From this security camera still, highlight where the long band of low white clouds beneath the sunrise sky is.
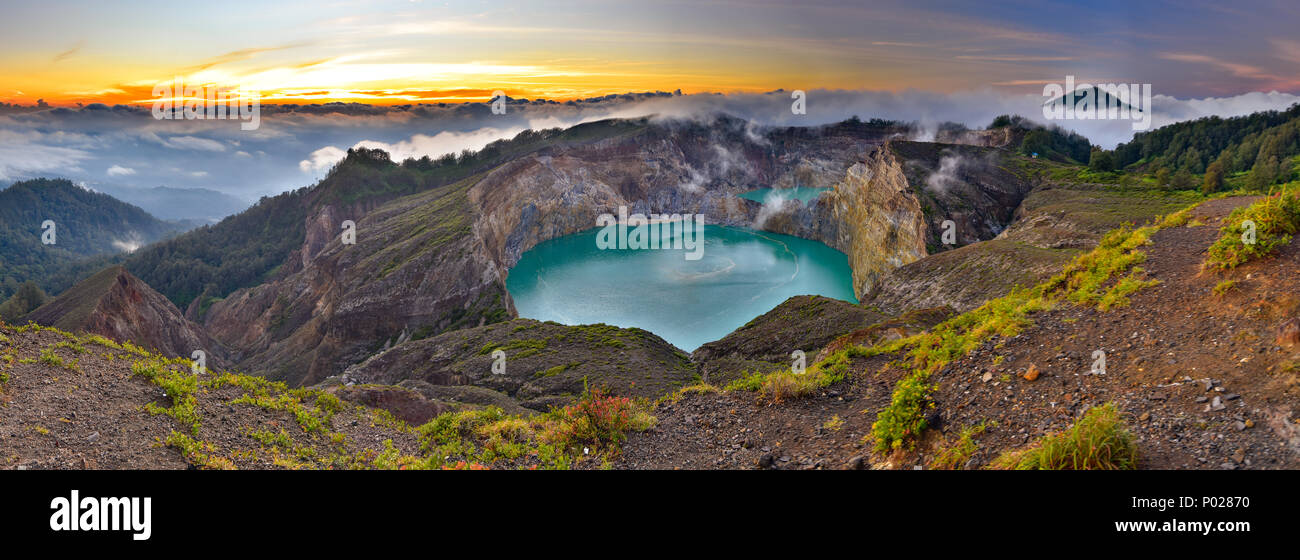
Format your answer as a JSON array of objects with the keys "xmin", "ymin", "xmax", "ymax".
[{"xmin": 0, "ymin": 86, "xmax": 1300, "ymax": 201}]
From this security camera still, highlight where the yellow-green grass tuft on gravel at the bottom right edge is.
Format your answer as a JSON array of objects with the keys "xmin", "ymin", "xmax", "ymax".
[{"xmin": 992, "ymin": 403, "xmax": 1138, "ymax": 470}]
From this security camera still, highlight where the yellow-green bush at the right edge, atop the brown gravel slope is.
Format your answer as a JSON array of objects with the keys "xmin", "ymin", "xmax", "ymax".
[{"xmin": 1205, "ymin": 183, "xmax": 1300, "ymax": 269}]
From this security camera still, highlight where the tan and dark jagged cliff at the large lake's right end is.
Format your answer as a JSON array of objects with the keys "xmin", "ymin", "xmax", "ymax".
[{"xmin": 755, "ymin": 140, "xmax": 1034, "ymax": 299}]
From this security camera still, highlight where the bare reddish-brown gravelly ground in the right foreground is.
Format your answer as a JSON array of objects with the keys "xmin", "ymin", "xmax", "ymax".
[{"xmin": 616, "ymin": 197, "xmax": 1300, "ymax": 469}]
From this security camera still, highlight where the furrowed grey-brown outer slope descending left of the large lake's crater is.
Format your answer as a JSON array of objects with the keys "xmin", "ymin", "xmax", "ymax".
[{"xmin": 204, "ymin": 183, "xmax": 510, "ymax": 385}]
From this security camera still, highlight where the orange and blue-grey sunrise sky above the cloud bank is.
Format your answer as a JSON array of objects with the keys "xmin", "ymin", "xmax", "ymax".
[{"xmin": 0, "ymin": 0, "xmax": 1300, "ymax": 107}]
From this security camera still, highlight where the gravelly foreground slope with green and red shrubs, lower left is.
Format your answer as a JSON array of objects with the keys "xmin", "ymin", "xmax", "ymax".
[{"xmin": 0, "ymin": 324, "xmax": 654, "ymax": 470}]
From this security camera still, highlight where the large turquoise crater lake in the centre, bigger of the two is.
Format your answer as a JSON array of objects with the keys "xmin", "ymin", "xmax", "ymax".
[{"xmin": 506, "ymin": 226, "xmax": 857, "ymax": 352}]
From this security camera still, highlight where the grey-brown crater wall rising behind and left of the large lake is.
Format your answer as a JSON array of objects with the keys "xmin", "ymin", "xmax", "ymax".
[{"xmin": 469, "ymin": 117, "xmax": 898, "ymax": 276}]
